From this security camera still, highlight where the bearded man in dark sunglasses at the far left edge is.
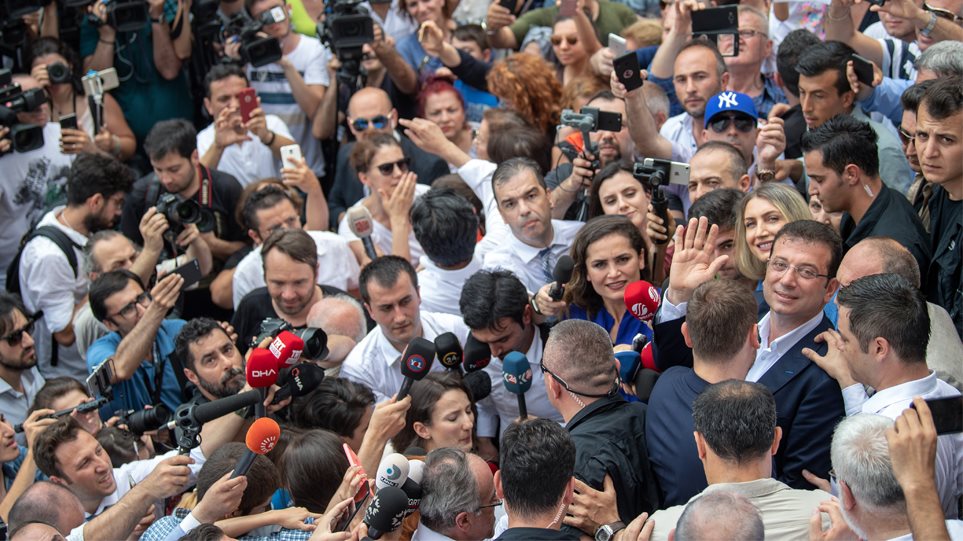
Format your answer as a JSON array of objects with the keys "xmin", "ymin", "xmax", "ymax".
[{"xmin": 0, "ymin": 292, "xmax": 44, "ymax": 438}]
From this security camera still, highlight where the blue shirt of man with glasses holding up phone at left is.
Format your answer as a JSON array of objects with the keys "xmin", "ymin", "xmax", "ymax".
[{"xmin": 87, "ymin": 319, "xmax": 185, "ymax": 419}]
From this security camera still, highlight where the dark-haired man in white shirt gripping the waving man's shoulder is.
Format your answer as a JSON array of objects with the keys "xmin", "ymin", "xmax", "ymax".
[{"xmin": 807, "ymin": 274, "xmax": 963, "ymax": 519}]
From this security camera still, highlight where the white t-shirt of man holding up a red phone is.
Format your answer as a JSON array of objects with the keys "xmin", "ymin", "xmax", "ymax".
[{"xmin": 197, "ymin": 115, "xmax": 294, "ymax": 186}]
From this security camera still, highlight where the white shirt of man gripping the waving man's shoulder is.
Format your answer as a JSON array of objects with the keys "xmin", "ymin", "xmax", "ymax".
[{"xmin": 843, "ymin": 370, "xmax": 963, "ymax": 518}]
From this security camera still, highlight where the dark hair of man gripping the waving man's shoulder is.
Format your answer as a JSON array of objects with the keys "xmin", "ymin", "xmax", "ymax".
[{"xmin": 836, "ymin": 273, "xmax": 930, "ymax": 363}]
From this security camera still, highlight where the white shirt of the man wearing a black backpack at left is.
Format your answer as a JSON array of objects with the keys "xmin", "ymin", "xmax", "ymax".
[{"xmin": 20, "ymin": 207, "xmax": 88, "ymax": 381}]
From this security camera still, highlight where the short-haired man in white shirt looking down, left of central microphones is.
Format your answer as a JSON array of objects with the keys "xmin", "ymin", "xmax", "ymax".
[{"xmin": 341, "ymin": 255, "xmax": 470, "ymax": 402}]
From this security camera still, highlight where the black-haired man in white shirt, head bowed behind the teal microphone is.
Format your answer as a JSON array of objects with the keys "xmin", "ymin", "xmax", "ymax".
[{"xmin": 459, "ymin": 270, "xmax": 563, "ymax": 457}]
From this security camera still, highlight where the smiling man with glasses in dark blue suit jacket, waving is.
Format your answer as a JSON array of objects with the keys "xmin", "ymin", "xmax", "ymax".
[{"xmin": 655, "ymin": 219, "xmax": 844, "ymax": 489}]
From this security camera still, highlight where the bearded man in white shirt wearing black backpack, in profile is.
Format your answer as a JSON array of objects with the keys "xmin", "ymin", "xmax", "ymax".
[{"xmin": 19, "ymin": 154, "xmax": 133, "ymax": 381}]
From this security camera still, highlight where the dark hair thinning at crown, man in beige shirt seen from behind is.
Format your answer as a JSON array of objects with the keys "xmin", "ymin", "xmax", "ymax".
[{"xmin": 692, "ymin": 379, "xmax": 776, "ymax": 463}]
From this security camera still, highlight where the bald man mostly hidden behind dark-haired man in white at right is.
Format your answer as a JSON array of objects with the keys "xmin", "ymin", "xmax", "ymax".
[{"xmin": 836, "ymin": 237, "xmax": 963, "ymax": 392}]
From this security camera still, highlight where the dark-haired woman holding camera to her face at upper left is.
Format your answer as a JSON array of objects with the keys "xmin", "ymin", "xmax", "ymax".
[{"xmin": 30, "ymin": 37, "xmax": 137, "ymax": 160}]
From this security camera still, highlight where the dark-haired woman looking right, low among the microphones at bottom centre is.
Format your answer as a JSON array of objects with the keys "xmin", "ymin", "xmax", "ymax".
[{"xmin": 391, "ymin": 372, "xmax": 475, "ymax": 454}]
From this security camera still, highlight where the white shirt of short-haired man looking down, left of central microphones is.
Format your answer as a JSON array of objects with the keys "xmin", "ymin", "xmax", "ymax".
[{"xmin": 341, "ymin": 311, "xmax": 468, "ymax": 402}]
